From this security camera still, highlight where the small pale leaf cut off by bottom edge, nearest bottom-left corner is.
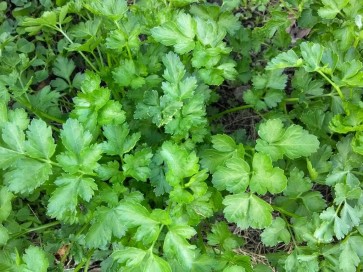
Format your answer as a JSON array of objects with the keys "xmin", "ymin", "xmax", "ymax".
[{"xmin": 22, "ymin": 246, "xmax": 49, "ymax": 272}]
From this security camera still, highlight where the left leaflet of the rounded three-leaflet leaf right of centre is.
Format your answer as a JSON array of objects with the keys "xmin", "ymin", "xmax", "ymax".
[{"xmin": 212, "ymin": 158, "xmax": 250, "ymax": 193}]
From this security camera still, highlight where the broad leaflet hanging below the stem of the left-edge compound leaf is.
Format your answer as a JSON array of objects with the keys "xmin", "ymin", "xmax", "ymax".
[{"xmin": 4, "ymin": 158, "xmax": 52, "ymax": 194}]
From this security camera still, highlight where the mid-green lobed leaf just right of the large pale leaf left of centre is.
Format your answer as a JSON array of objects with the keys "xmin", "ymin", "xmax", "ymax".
[{"xmin": 102, "ymin": 123, "xmax": 141, "ymax": 156}]
